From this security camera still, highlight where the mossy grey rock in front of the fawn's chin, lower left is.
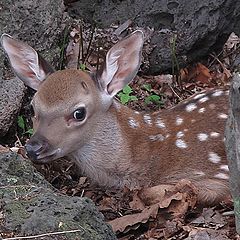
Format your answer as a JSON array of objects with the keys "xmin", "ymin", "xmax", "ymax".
[{"xmin": 0, "ymin": 152, "xmax": 116, "ymax": 240}]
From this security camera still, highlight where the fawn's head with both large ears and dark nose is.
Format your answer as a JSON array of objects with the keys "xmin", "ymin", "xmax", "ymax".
[{"xmin": 1, "ymin": 31, "xmax": 143, "ymax": 163}]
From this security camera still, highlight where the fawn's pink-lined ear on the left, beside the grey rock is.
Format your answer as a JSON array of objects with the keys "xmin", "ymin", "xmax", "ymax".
[{"xmin": 0, "ymin": 34, "xmax": 54, "ymax": 90}]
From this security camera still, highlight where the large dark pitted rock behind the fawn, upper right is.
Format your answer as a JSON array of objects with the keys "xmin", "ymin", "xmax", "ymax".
[{"xmin": 68, "ymin": 0, "xmax": 240, "ymax": 74}]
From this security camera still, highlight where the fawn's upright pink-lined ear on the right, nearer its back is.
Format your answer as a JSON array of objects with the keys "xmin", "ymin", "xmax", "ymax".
[{"xmin": 98, "ymin": 30, "xmax": 144, "ymax": 97}]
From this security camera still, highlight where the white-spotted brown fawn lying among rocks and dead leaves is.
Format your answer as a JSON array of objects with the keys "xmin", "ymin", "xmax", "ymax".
[{"xmin": 1, "ymin": 30, "xmax": 230, "ymax": 205}]
